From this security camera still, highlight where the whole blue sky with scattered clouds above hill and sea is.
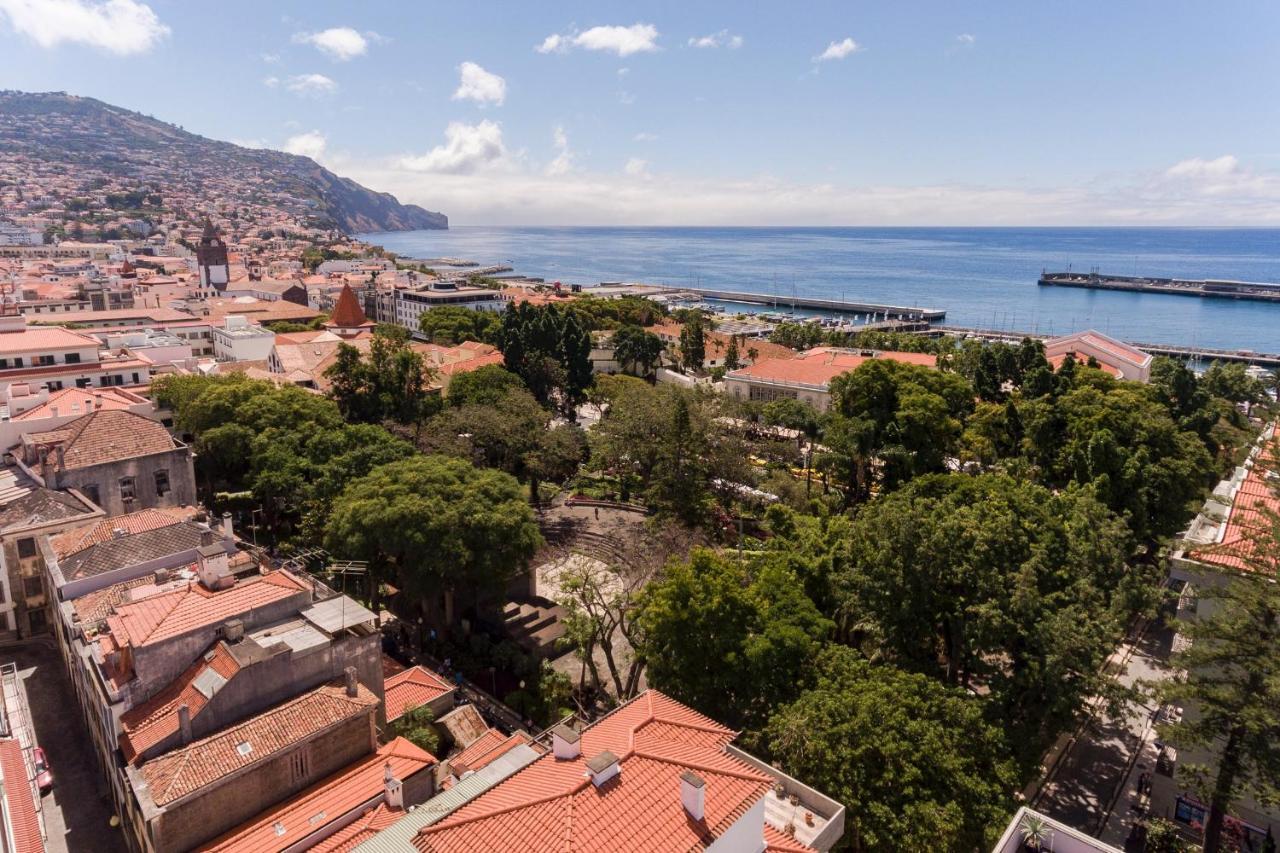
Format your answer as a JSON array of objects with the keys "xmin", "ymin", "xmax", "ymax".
[{"xmin": 0, "ymin": 0, "xmax": 1280, "ymax": 224}]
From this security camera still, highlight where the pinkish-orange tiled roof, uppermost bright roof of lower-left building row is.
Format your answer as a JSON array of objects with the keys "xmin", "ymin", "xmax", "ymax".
[{"xmin": 106, "ymin": 569, "xmax": 306, "ymax": 648}]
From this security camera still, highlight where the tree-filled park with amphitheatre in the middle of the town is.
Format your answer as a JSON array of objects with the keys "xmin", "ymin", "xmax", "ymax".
[{"xmin": 155, "ymin": 300, "xmax": 1280, "ymax": 850}]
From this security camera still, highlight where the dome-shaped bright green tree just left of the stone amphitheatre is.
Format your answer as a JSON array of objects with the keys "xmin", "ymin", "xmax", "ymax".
[{"xmin": 325, "ymin": 456, "xmax": 541, "ymax": 617}]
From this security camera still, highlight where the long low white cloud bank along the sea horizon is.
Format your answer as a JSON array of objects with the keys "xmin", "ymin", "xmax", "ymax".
[{"xmin": 346, "ymin": 151, "xmax": 1280, "ymax": 227}]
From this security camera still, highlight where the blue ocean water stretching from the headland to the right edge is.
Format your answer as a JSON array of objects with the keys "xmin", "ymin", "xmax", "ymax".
[{"xmin": 364, "ymin": 227, "xmax": 1280, "ymax": 352}]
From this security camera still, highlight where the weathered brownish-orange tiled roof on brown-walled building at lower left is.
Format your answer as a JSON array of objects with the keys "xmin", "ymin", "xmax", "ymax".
[{"xmin": 138, "ymin": 684, "xmax": 378, "ymax": 806}]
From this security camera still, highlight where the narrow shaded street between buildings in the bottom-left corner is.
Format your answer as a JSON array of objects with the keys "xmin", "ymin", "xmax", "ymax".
[{"xmin": 0, "ymin": 643, "xmax": 125, "ymax": 853}]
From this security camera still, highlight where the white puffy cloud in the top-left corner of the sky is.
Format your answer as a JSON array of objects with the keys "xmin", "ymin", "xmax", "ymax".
[{"xmin": 0, "ymin": 0, "xmax": 170, "ymax": 56}]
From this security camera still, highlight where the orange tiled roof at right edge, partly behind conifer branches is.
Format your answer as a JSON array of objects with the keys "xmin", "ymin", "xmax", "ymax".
[{"xmin": 1190, "ymin": 435, "xmax": 1280, "ymax": 578}]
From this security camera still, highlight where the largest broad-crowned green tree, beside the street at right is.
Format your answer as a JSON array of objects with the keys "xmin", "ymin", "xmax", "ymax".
[{"xmin": 836, "ymin": 474, "xmax": 1135, "ymax": 758}]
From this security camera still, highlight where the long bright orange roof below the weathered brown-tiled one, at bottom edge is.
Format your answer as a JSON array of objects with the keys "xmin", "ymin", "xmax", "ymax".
[{"xmin": 198, "ymin": 738, "xmax": 435, "ymax": 853}]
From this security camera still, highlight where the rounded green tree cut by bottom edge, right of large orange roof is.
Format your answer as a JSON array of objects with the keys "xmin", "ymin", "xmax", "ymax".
[{"xmin": 767, "ymin": 646, "xmax": 1016, "ymax": 852}]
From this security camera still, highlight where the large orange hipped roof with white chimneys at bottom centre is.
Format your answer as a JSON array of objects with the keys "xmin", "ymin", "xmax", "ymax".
[{"xmin": 413, "ymin": 690, "xmax": 772, "ymax": 853}]
